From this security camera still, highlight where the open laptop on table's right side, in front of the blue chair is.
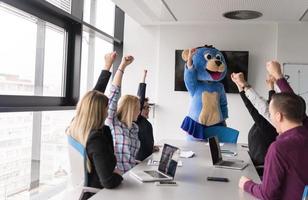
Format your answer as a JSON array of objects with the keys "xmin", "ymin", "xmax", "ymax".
[{"xmin": 208, "ymin": 136, "xmax": 248, "ymax": 170}]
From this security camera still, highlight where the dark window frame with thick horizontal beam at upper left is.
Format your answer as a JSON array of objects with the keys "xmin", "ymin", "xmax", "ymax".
[{"xmin": 0, "ymin": 0, "xmax": 125, "ymax": 112}]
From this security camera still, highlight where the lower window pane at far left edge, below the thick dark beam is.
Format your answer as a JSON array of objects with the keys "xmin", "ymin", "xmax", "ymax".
[{"xmin": 0, "ymin": 112, "xmax": 33, "ymax": 199}]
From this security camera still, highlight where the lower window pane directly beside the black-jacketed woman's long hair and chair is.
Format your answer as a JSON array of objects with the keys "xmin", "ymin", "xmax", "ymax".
[{"xmin": 40, "ymin": 110, "xmax": 75, "ymax": 192}]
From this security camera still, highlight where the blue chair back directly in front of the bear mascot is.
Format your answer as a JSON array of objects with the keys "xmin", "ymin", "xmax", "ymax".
[{"xmin": 205, "ymin": 126, "xmax": 239, "ymax": 144}]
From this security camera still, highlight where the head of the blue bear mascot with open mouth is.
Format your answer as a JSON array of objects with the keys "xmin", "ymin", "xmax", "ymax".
[{"xmin": 182, "ymin": 45, "xmax": 227, "ymax": 81}]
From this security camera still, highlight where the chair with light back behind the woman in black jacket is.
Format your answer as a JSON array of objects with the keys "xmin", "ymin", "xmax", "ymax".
[{"xmin": 67, "ymin": 136, "xmax": 100, "ymax": 200}]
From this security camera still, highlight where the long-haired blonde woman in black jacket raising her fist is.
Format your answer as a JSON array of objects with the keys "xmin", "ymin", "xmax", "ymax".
[{"xmin": 66, "ymin": 52, "xmax": 123, "ymax": 199}]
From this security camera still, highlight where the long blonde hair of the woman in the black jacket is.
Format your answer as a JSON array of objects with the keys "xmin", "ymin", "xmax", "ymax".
[{"xmin": 66, "ymin": 90, "xmax": 108, "ymax": 147}]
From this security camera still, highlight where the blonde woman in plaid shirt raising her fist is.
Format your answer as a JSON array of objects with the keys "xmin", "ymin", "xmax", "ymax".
[{"xmin": 106, "ymin": 56, "xmax": 140, "ymax": 173}]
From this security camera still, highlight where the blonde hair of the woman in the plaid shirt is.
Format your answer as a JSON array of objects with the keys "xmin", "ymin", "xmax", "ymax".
[{"xmin": 117, "ymin": 95, "xmax": 140, "ymax": 128}]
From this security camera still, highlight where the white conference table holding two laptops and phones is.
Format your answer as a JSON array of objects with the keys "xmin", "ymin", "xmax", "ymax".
[{"xmin": 90, "ymin": 140, "xmax": 260, "ymax": 200}]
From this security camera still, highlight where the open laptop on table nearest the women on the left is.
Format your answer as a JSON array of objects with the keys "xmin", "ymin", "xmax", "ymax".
[{"xmin": 130, "ymin": 144, "xmax": 180, "ymax": 182}]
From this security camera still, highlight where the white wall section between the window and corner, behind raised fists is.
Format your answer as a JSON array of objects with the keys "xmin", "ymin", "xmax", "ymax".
[{"xmin": 122, "ymin": 15, "xmax": 159, "ymax": 102}]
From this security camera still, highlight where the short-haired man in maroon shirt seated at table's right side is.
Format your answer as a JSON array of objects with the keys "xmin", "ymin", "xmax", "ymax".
[{"xmin": 239, "ymin": 63, "xmax": 308, "ymax": 200}]
